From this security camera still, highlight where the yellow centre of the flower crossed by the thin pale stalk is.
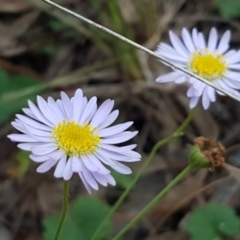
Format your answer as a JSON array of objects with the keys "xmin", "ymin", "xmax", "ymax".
[{"xmin": 189, "ymin": 50, "xmax": 227, "ymax": 81}]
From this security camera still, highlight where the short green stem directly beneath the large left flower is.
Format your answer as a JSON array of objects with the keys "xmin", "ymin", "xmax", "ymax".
[{"xmin": 54, "ymin": 181, "xmax": 69, "ymax": 240}]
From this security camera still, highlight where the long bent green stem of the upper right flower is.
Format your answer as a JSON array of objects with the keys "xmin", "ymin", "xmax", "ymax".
[{"xmin": 91, "ymin": 109, "xmax": 195, "ymax": 240}]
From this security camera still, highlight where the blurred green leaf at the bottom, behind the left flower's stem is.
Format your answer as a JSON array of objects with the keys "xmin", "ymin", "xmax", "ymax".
[{"xmin": 44, "ymin": 196, "xmax": 112, "ymax": 240}]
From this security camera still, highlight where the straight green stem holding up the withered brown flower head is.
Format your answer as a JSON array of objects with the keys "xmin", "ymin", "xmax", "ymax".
[{"xmin": 112, "ymin": 165, "xmax": 194, "ymax": 240}]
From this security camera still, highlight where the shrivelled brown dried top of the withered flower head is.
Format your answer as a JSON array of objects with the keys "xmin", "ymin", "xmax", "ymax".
[{"xmin": 194, "ymin": 137, "xmax": 226, "ymax": 171}]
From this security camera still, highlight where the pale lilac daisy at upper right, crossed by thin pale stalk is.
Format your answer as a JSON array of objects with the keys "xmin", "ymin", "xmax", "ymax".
[{"xmin": 155, "ymin": 28, "xmax": 240, "ymax": 109}]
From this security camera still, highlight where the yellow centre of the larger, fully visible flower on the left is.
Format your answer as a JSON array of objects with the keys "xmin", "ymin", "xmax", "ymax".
[{"xmin": 52, "ymin": 120, "xmax": 100, "ymax": 156}]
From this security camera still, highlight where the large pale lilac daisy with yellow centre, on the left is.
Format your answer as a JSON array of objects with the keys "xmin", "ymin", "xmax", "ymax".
[{"xmin": 8, "ymin": 89, "xmax": 141, "ymax": 193}]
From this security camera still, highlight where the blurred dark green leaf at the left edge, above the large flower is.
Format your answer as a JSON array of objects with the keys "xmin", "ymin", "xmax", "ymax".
[{"xmin": 0, "ymin": 69, "xmax": 44, "ymax": 121}]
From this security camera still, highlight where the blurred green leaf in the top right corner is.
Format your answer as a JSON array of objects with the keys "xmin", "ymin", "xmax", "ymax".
[{"xmin": 214, "ymin": 0, "xmax": 240, "ymax": 18}]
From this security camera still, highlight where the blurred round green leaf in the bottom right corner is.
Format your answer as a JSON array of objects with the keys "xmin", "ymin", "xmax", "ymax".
[{"xmin": 186, "ymin": 202, "xmax": 240, "ymax": 240}]
